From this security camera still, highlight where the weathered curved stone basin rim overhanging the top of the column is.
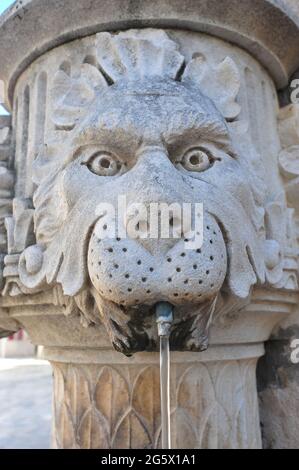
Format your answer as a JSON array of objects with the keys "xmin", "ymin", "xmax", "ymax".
[{"xmin": 0, "ymin": 0, "xmax": 299, "ymax": 107}]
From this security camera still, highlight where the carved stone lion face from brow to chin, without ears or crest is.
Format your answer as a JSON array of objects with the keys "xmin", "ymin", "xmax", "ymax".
[{"xmin": 20, "ymin": 29, "xmax": 264, "ymax": 353}]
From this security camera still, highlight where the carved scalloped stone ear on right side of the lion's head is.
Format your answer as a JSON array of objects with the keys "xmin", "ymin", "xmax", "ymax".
[{"xmin": 182, "ymin": 55, "xmax": 241, "ymax": 121}]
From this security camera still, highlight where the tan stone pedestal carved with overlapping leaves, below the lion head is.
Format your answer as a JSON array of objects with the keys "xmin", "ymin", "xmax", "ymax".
[{"xmin": 45, "ymin": 345, "xmax": 263, "ymax": 449}]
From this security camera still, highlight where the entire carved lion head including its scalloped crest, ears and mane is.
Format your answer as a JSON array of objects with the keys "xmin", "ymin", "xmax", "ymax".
[{"xmin": 4, "ymin": 29, "xmax": 296, "ymax": 354}]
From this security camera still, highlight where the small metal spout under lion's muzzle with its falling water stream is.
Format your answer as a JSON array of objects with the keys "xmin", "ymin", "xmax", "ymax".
[{"xmin": 156, "ymin": 302, "xmax": 173, "ymax": 449}]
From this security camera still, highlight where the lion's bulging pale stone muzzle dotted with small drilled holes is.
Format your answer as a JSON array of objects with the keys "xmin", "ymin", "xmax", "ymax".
[{"xmin": 88, "ymin": 215, "xmax": 227, "ymax": 307}]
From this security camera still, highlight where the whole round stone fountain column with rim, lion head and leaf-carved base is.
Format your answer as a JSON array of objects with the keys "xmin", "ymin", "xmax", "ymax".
[{"xmin": 0, "ymin": 0, "xmax": 299, "ymax": 449}]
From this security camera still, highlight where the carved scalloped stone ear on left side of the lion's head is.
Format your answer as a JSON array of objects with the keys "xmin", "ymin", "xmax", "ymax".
[{"xmin": 51, "ymin": 64, "xmax": 108, "ymax": 130}]
